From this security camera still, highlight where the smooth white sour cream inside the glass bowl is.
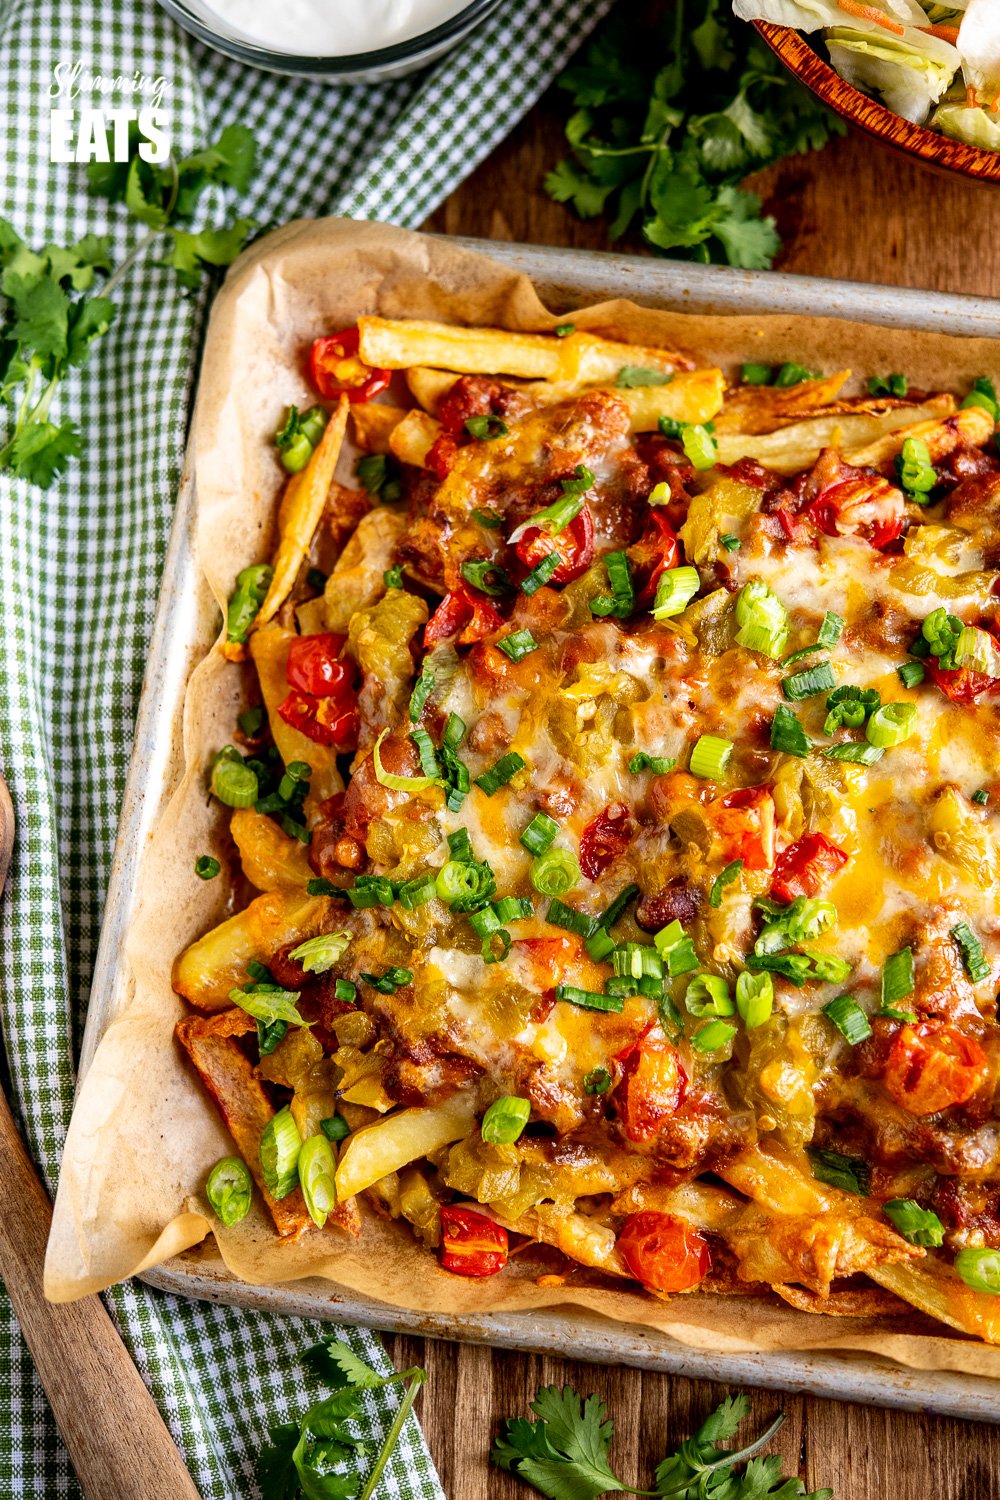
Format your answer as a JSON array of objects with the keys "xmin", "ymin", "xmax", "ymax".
[{"xmin": 190, "ymin": 0, "xmax": 469, "ymax": 57}]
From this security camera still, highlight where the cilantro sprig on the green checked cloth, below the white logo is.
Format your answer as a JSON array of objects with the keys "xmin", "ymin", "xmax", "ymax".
[{"xmin": 0, "ymin": 125, "xmax": 255, "ymax": 489}]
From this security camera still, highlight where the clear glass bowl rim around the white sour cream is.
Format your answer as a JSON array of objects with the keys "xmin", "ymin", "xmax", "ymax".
[{"xmin": 159, "ymin": 0, "xmax": 501, "ymax": 84}]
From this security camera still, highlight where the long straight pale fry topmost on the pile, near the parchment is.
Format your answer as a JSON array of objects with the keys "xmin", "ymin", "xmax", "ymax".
[{"xmin": 358, "ymin": 318, "xmax": 691, "ymax": 384}]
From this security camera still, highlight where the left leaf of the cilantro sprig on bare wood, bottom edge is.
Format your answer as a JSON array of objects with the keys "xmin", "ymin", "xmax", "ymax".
[{"xmin": 492, "ymin": 1386, "xmax": 625, "ymax": 1500}]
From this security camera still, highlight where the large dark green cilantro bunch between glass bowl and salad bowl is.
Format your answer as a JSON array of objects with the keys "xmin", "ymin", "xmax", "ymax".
[{"xmin": 546, "ymin": 0, "xmax": 844, "ymax": 270}]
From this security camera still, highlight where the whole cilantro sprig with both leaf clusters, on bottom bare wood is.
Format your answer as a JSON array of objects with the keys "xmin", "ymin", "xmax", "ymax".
[{"xmin": 490, "ymin": 1386, "xmax": 834, "ymax": 1500}]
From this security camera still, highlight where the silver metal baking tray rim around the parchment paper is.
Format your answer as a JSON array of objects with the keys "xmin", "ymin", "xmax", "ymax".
[{"xmin": 79, "ymin": 240, "xmax": 1000, "ymax": 1422}]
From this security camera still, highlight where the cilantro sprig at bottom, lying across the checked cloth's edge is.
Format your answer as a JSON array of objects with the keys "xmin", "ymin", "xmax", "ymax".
[{"xmin": 256, "ymin": 1338, "xmax": 427, "ymax": 1500}]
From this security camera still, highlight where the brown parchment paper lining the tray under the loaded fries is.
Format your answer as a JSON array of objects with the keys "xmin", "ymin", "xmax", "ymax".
[{"xmin": 45, "ymin": 219, "xmax": 1000, "ymax": 1376}]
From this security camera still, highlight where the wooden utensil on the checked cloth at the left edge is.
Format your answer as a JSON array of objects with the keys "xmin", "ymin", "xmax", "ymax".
[{"xmin": 0, "ymin": 779, "xmax": 198, "ymax": 1500}]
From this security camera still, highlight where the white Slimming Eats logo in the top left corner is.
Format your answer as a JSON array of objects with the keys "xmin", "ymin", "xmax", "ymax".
[{"xmin": 48, "ymin": 62, "xmax": 171, "ymax": 164}]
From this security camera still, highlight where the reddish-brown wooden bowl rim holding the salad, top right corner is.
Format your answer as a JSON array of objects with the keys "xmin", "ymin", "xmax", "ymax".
[{"xmin": 754, "ymin": 21, "xmax": 1000, "ymax": 183}]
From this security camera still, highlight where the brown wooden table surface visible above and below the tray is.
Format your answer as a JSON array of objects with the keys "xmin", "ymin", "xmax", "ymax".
[{"xmin": 404, "ymin": 79, "xmax": 1000, "ymax": 1500}]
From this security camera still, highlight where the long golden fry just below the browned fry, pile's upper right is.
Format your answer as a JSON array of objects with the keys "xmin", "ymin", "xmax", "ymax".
[{"xmin": 717, "ymin": 396, "xmax": 955, "ymax": 474}]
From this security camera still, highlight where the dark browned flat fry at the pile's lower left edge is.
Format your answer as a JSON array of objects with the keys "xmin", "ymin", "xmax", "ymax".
[{"xmin": 175, "ymin": 1011, "xmax": 312, "ymax": 1239}]
